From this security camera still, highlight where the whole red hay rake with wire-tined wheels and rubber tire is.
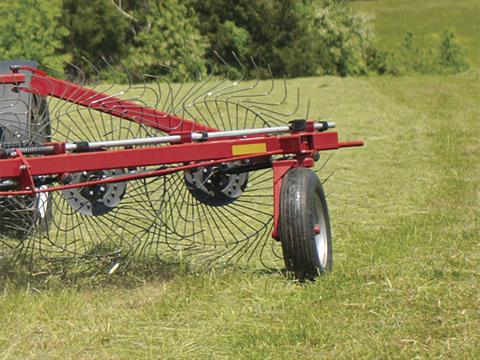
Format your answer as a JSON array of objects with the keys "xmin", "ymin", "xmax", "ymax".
[{"xmin": 0, "ymin": 62, "xmax": 362, "ymax": 278}]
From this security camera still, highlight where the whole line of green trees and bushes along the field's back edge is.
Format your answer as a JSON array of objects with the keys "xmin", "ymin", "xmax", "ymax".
[{"xmin": 0, "ymin": 0, "xmax": 468, "ymax": 81}]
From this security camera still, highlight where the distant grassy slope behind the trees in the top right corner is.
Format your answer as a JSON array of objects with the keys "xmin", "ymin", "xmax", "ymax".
[{"xmin": 351, "ymin": 0, "xmax": 480, "ymax": 67}]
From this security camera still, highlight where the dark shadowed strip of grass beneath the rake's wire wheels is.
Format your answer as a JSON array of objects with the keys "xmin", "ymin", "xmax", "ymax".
[{"xmin": 0, "ymin": 257, "xmax": 288, "ymax": 291}]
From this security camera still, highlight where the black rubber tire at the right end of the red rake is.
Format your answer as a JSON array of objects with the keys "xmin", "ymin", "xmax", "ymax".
[{"xmin": 279, "ymin": 168, "xmax": 333, "ymax": 280}]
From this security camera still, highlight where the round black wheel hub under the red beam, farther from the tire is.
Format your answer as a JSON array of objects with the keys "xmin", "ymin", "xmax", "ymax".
[{"xmin": 62, "ymin": 169, "xmax": 127, "ymax": 216}]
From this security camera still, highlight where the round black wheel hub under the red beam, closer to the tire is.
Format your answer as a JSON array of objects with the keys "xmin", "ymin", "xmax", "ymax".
[{"xmin": 185, "ymin": 161, "xmax": 248, "ymax": 206}]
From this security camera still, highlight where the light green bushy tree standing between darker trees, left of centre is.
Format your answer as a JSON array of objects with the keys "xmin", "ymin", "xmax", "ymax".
[{"xmin": 125, "ymin": 0, "xmax": 206, "ymax": 80}]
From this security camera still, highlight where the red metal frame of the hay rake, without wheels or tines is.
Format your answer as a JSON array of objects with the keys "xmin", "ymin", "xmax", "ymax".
[{"xmin": 0, "ymin": 66, "xmax": 363, "ymax": 276}]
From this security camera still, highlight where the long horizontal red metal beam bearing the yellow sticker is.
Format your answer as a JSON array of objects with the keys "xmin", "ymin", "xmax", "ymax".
[{"xmin": 0, "ymin": 132, "xmax": 338, "ymax": 178}]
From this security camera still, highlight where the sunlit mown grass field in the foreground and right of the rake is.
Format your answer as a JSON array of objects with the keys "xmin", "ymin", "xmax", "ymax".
[{"xmin": 0, "ymin": 71, "xmax": 480, "ymax": 359}]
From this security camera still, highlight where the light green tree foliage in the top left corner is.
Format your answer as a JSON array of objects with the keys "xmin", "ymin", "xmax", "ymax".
[{"xmin": 0, "ymin": 0, "xmax": 70, "ymax": 70}]
